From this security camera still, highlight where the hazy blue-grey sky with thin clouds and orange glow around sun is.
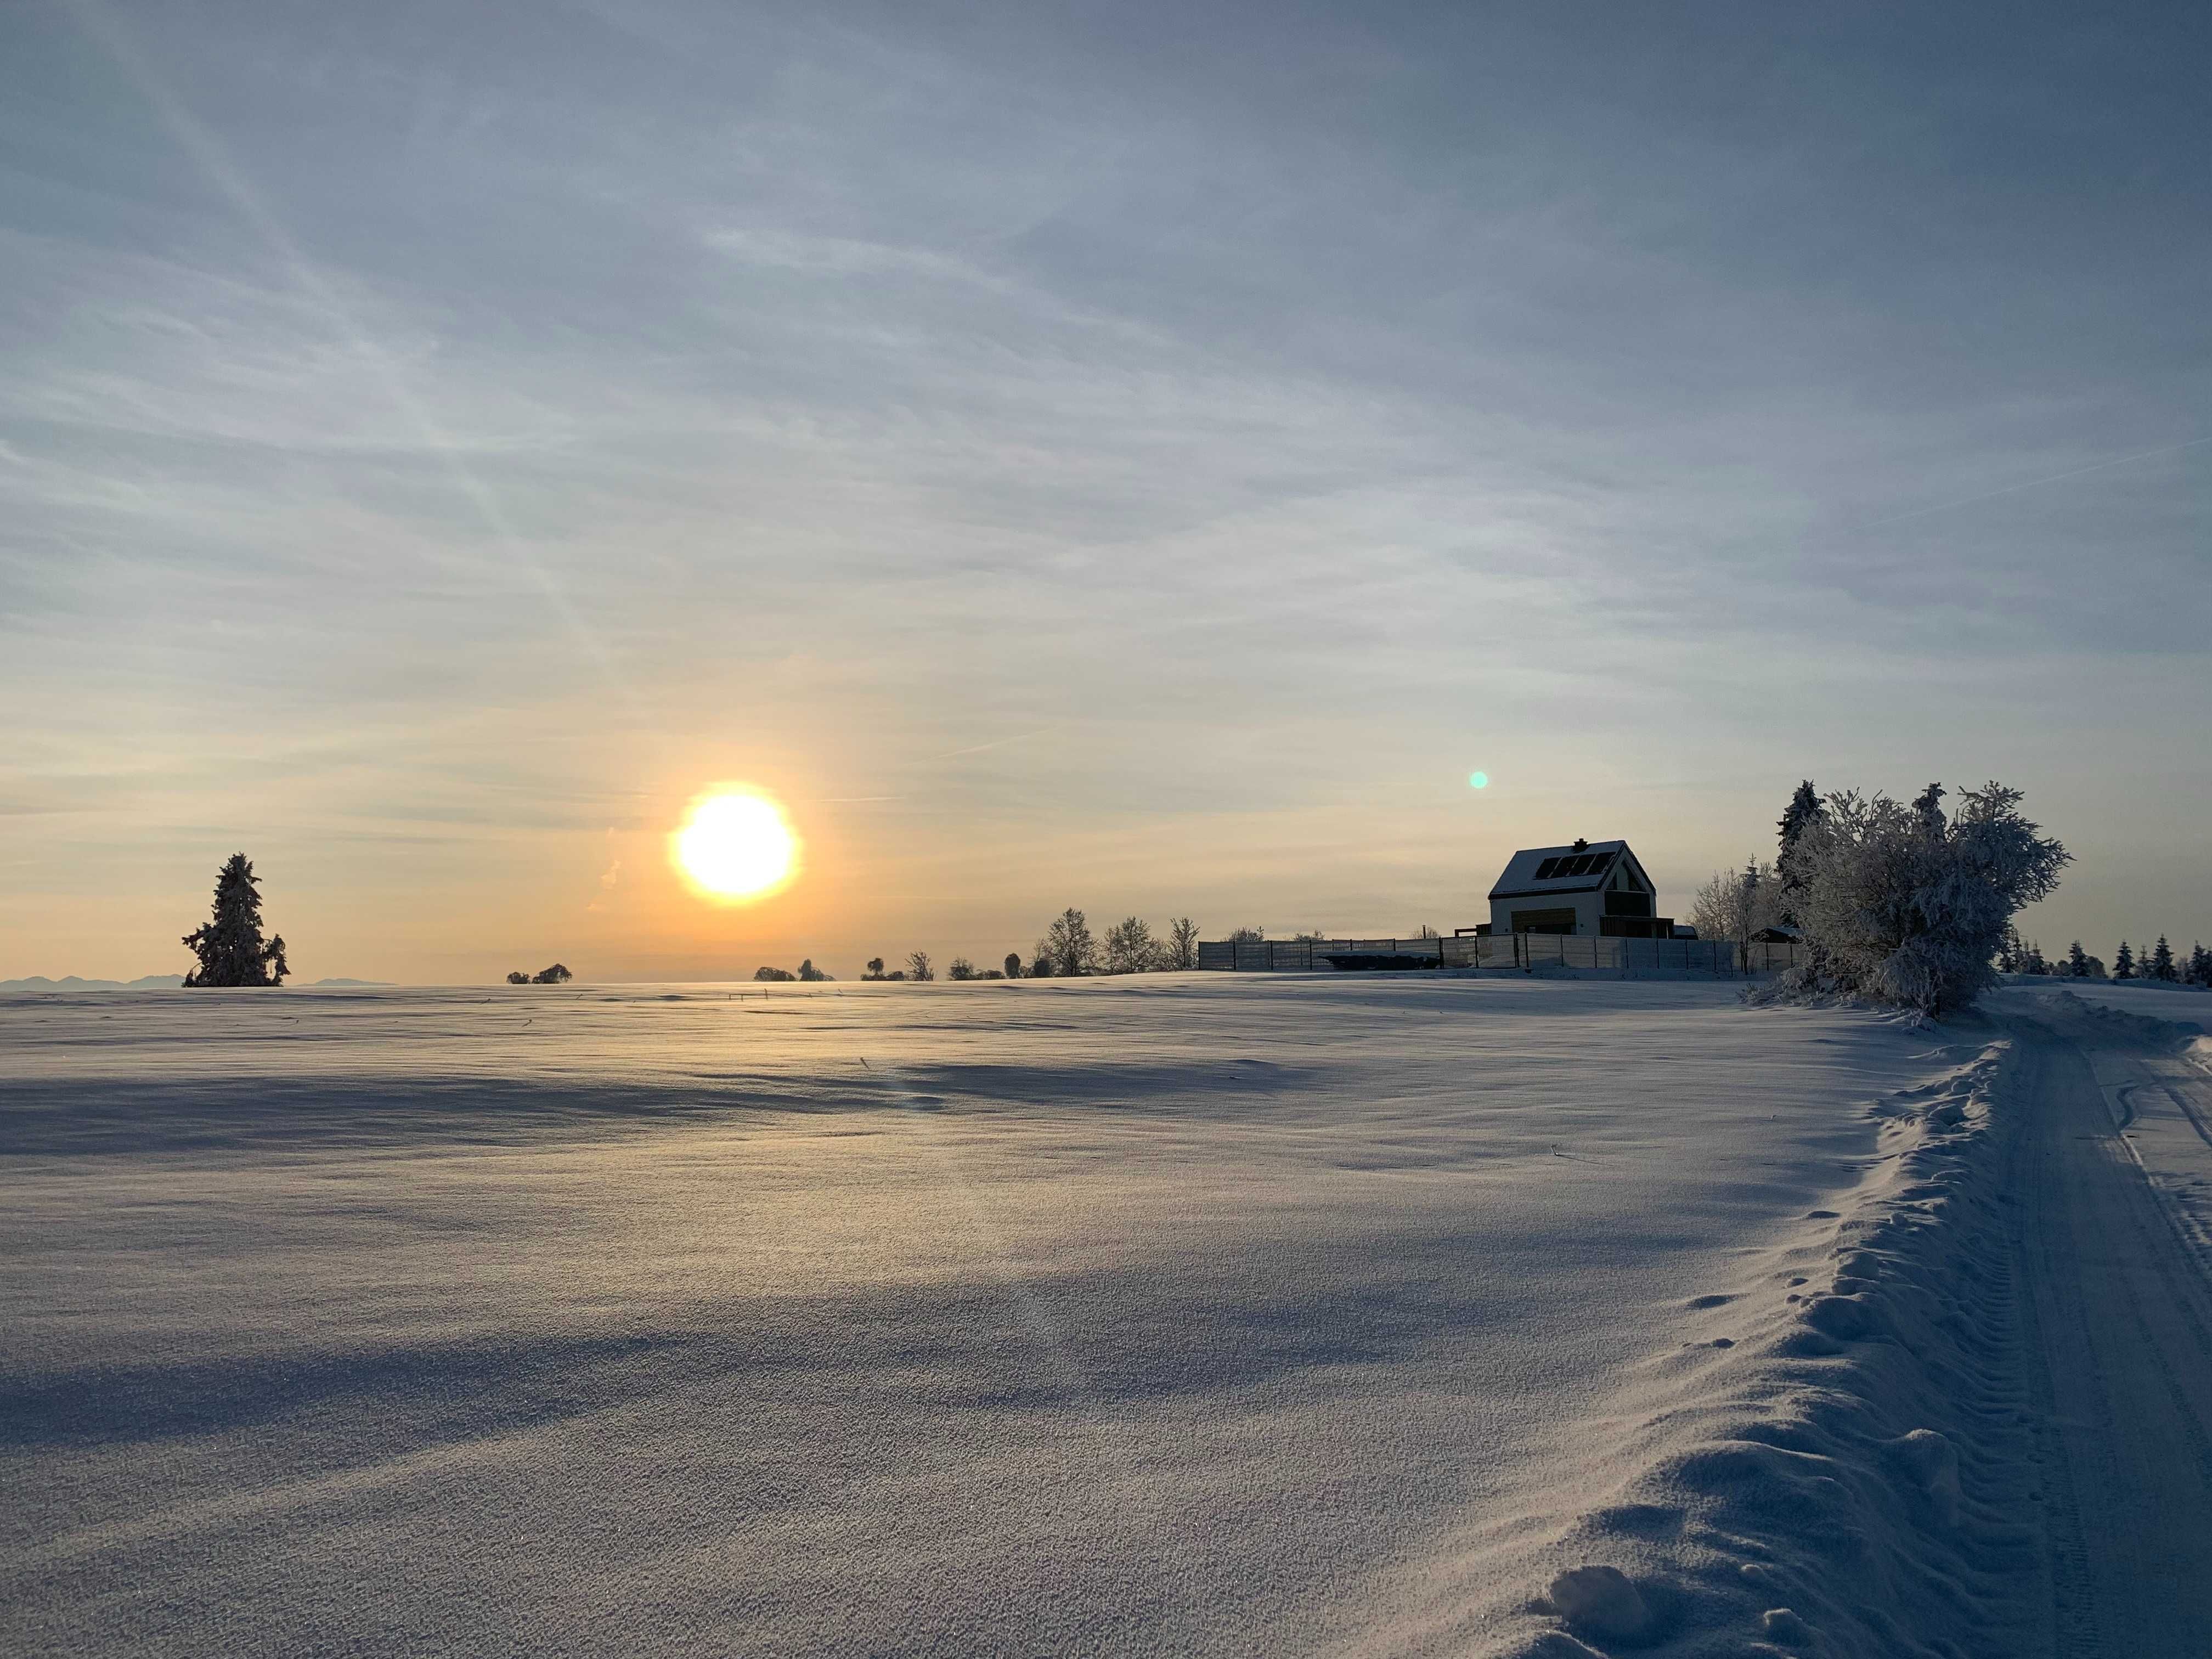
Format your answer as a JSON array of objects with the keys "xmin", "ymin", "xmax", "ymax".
[{"xmin": 0, "ymin": 0, "xmax": 2212, "ymax": 982}]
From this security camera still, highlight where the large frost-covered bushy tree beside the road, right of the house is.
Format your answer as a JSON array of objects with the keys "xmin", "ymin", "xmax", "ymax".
[{"xmin": 1754, "ymin": 783, "xmax": 2070, "ymax": 1015}]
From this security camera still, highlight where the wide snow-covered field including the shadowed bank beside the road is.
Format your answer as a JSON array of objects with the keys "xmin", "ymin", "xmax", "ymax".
[{"xmin": 0, "ymin": 975, "xmax": 2042, "ymax": 1657}]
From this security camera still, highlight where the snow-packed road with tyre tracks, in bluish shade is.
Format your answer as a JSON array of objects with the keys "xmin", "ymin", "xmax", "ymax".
[{"xmin": 1995, "ymin": 991, "xmax": 2212, "ymax": 1659}]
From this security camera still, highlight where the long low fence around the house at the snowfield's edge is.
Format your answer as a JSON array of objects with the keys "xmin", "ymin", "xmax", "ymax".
[{"xmin": 1199, "ymin": 934, "xmax": 1801, "ymax": 980}]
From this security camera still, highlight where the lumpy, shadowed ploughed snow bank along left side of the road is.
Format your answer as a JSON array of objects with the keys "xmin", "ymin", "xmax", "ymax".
[{"xmin": 1493, "ymin": 1042, "xmax": 2044, "ymax": 1659}]
